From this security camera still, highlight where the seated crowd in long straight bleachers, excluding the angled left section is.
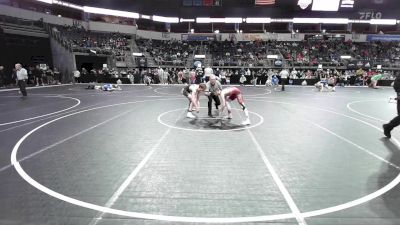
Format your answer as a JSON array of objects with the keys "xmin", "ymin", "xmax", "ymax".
[{"xmin": 132, "ymin": 39, "xmax": 400, "ymax": 68}]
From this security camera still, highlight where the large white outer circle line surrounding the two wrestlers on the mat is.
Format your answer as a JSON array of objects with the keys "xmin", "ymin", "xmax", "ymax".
[{"xmin": 11, "ymin": 99, "xmax": 400, "ymax": 223}]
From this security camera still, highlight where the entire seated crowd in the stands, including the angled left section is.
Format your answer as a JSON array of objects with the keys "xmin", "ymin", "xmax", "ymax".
[{"xmin": 46, "ymin": 22, "xmax": 400, "ymax": 68}]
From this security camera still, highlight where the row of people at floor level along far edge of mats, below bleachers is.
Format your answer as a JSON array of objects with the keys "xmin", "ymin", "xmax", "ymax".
[{"xmin": 67, "ymin": 63, "xmax": 395, "ymax": 86}]
